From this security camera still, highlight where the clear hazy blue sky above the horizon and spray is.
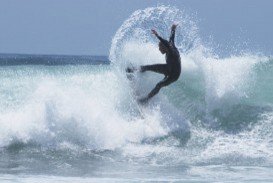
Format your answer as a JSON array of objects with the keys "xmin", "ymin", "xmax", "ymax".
[{"xmin": 0, "ymin": 0, "xmax": 273, "ymax": 55}]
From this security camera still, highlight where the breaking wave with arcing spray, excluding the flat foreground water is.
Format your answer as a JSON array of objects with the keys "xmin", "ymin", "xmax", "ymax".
[{"xmin": 0, "ymin": 6, "xmax": 273, "ymax": 170}]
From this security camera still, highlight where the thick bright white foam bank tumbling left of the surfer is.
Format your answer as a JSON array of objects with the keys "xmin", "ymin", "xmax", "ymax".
[{"xmin": 0, "ymin": 67, "xmax": 176, "ymax": 149}]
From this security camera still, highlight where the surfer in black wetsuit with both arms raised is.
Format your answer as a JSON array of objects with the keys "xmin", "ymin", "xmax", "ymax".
[{"xmin": 126, "ymin": 24, "xmax": 181, "ymax": 103}]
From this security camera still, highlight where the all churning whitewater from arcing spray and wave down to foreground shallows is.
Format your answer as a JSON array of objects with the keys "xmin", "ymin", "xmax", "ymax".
[{"xmin": 0, "ymin": 6, "xmax": 273, "ymax": 182}]
